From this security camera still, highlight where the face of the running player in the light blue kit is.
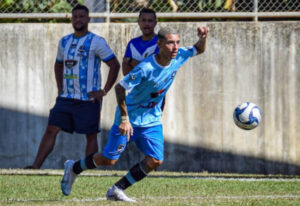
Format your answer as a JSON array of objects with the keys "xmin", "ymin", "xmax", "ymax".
[{"xmin": 158, "ymin": 34, "xmax": 180, "ymax": 59}]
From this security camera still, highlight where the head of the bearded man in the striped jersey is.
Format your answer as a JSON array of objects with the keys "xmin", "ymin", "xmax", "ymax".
[{"xmin": 72, "ymin": 9, "xmax": 90, "ymax": 31}]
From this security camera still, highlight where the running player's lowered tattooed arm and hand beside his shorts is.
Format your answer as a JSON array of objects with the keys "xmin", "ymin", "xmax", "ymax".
[{"xmin": 115, "ymin": 84, "xmax": 133, "ymax": 141}]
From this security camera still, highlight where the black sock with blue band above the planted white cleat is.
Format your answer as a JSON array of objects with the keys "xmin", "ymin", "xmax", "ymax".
[{"xmin": 115, "ymin": 162, "xmax": 148, "ymax": 190}]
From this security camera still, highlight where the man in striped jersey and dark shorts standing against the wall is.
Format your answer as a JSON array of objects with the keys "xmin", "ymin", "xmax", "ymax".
[{"xmin": 27, "ymin": 5, "xmax": 120, "ymax": 169}]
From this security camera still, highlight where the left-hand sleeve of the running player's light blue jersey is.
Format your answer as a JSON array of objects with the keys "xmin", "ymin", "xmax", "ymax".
[{"xmin": 119, "ymin": 65, "xmax": 145, "ymax": 90}]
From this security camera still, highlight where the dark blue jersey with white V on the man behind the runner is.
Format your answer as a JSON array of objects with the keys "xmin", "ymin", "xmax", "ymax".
[{"xmin": 124, "ymin": 35, "xmax": 159, "ymax": 61}]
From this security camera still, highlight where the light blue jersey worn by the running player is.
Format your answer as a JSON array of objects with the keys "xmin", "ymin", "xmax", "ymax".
[{"xmin": 115, "ymin": 47, "xmax": 197, "ymax": 127}]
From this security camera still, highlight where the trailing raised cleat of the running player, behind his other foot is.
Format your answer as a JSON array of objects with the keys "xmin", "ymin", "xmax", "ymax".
[{"xmin": 60, "ymin": 160, "xmax": 77, "ymax": 195}]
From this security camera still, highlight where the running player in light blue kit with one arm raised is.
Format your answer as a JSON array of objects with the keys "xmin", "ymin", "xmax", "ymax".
[{"xmin": 61, "ymin": 27, "xmax": 209, "ymax": 202}]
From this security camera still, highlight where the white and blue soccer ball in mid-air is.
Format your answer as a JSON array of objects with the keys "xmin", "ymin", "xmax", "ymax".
[{"xmin": 233, "ymin": 102, "xmax": 262, "ymax": 130}]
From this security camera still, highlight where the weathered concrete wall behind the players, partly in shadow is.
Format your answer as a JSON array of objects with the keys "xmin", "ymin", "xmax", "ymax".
[{"xmin": 0, "ymin": 22, "xmax": 300, "ymax": 174}]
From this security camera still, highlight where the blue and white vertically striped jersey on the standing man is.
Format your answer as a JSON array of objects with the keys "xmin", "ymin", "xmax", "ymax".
[{"xmin": 56, "ymin": 32, "xmax": 115, "ymax": 100}]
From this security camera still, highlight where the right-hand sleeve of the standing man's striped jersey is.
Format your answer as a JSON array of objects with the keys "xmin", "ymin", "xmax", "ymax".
[{"xmin": 95, "ymin": 38, "xmax": 115, "ymax": 62}]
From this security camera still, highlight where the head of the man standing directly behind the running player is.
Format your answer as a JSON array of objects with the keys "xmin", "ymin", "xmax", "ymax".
[{"xmin": 138, "ymin": 13, "xmax": 156, "ymax": 36}]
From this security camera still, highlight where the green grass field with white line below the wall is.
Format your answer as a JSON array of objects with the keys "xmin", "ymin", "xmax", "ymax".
[{"xmin": 0, "ymin": 169, "xmax": 300, "ymax": 206}]
